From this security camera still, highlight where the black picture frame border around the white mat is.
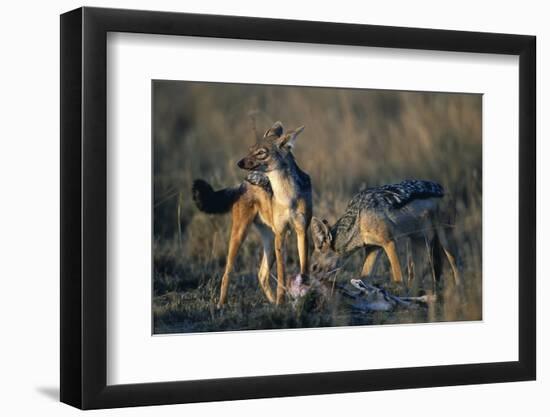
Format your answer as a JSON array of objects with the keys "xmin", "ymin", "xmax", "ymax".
[{"xmin": 60, "ymin": 7, "xmax": 536, "ymax": 409}]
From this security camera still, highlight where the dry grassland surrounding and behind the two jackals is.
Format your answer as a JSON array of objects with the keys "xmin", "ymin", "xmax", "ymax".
[{"xmin": 152, "ymin": 81, "xmax": 482, "ymax": 333}]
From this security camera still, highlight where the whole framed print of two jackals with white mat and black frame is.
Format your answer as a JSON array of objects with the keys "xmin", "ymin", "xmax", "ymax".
[{"xmin": 61, "ymin": 8, "xmax": 536, "ymax": 409}]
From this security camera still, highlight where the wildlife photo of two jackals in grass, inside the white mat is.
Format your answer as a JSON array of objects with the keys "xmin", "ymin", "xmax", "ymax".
[{"xmin": 150, "ymin": 79, "xmax": 483, "ymax": 335}]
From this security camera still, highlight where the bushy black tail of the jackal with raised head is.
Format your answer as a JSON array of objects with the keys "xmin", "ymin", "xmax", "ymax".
[{"xmin": 192, "ymin": 180, "xmax": 243, "ymax": 214}]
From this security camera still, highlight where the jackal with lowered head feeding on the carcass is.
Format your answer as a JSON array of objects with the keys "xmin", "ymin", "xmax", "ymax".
[{"xmin": 311, "ymin": 180, "xmax": 460, "ymax": 285}]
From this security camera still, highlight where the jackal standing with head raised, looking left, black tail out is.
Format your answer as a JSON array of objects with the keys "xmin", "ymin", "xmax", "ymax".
[{"xmin": 193, "ymin": 122, "xmax": 312, "ymax": 307}]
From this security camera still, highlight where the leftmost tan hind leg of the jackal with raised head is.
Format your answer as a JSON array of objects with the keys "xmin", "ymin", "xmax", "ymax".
[{"xmin": 218, "ymin": 202, "xmax": 256, "ymax": 308}]
